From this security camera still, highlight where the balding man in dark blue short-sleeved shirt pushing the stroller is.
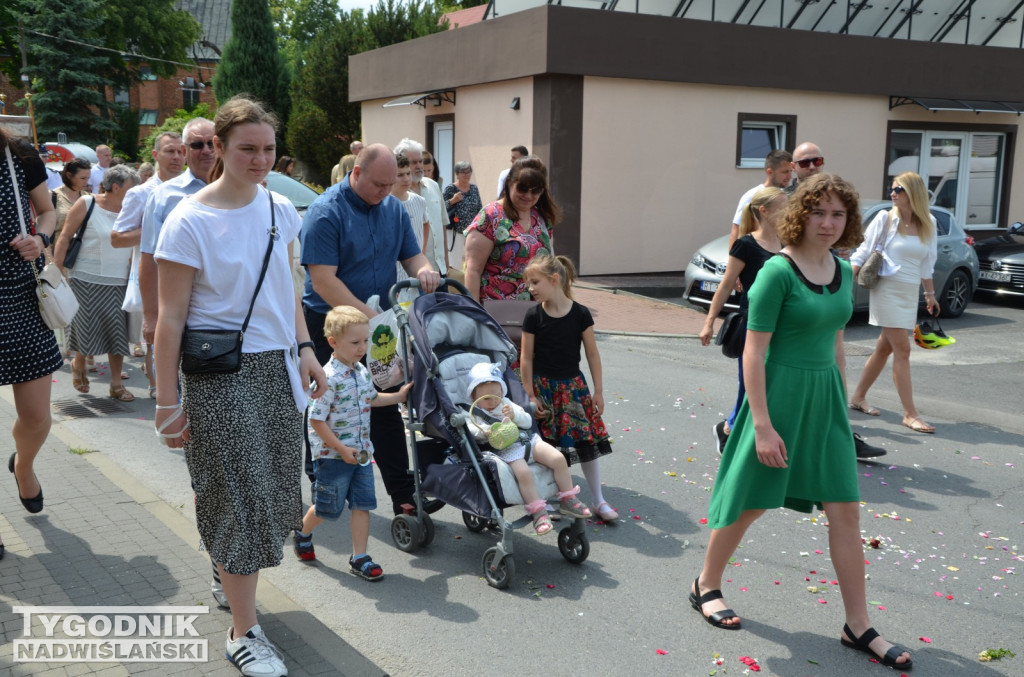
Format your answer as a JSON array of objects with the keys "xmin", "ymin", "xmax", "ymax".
[{"xmin": 301, "ymin": 143, "xmax": 440, "ymax": 514}]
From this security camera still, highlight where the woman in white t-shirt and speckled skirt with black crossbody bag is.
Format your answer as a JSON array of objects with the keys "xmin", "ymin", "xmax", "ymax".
[{"xmin": 154, "ymin": 96, "xmax": 326, "ymax": 675}]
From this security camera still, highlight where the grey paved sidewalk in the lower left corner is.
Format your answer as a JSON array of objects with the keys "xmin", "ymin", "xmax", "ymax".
[{"xmin": 0, "ymin": 389, "xmax": 384, "ymax": 677}]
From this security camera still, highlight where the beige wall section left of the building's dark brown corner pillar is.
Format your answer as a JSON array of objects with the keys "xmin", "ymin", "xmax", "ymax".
[{"xmin": 362, "ymin": 78, "xmax": 534, "ymax": 195}]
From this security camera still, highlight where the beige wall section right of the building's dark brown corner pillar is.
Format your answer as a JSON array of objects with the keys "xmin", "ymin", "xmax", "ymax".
[{"xmin": 580, "ymin": 77, "xmax": 1024, "ymax": 274}]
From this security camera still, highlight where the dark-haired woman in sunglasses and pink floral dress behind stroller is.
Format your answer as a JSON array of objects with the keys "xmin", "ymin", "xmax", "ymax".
[{"xmin": 465, "ymin": 157, "xmax": 561, "ymax": 301}]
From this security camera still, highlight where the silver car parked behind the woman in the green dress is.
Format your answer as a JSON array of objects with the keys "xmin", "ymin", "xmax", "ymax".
[{"xmin": 683, "ymin": 202, "xmax": 979, "ymax": 318}]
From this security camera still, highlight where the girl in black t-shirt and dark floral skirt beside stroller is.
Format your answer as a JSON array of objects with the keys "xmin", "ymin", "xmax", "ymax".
[{"xmin": 520, "ymin": 254, "xmax": 618, "ymax": 521}]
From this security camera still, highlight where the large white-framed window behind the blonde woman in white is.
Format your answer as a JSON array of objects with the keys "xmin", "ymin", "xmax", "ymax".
[{"xmin": 883, "ymin": 123, "xmax": 1011, "ymax": 228}]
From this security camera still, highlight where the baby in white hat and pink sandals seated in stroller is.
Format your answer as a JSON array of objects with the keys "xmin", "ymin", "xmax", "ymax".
[{"xmin": 467, "ymin": 363, "xmax": 591, "ymax": 534}]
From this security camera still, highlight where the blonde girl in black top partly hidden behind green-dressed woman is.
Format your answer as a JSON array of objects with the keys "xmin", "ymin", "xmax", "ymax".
[{"xmin": 698, "ymin": 186, "xmax": 786, "ymax": 446}]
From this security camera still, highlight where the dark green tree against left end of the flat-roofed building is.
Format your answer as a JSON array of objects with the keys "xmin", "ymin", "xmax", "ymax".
[{"xmin": 288, "ymin": 0, "xmax": 447, "ymax": 183}]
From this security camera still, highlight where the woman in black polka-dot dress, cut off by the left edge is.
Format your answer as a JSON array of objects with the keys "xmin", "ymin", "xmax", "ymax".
[{"xmin": 0, "ymin": 128, "xmax": 62, "ymax": 544}]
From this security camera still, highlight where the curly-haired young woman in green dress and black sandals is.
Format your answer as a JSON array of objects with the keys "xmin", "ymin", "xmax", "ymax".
[{"xmin": 689, "ymin": 174, "xmax": 912, "ymax": 670}]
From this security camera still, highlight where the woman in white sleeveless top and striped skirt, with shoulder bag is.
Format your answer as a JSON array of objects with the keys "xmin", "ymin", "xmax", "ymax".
[{"xmin": 53, "ymin": 165, "xmax": 139, "ymax": 401}]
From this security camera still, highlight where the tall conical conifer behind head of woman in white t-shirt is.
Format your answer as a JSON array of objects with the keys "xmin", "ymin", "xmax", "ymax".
[{"xmin": 213, "ymin": 0, "xmax": 290, "ymax": 122}]
